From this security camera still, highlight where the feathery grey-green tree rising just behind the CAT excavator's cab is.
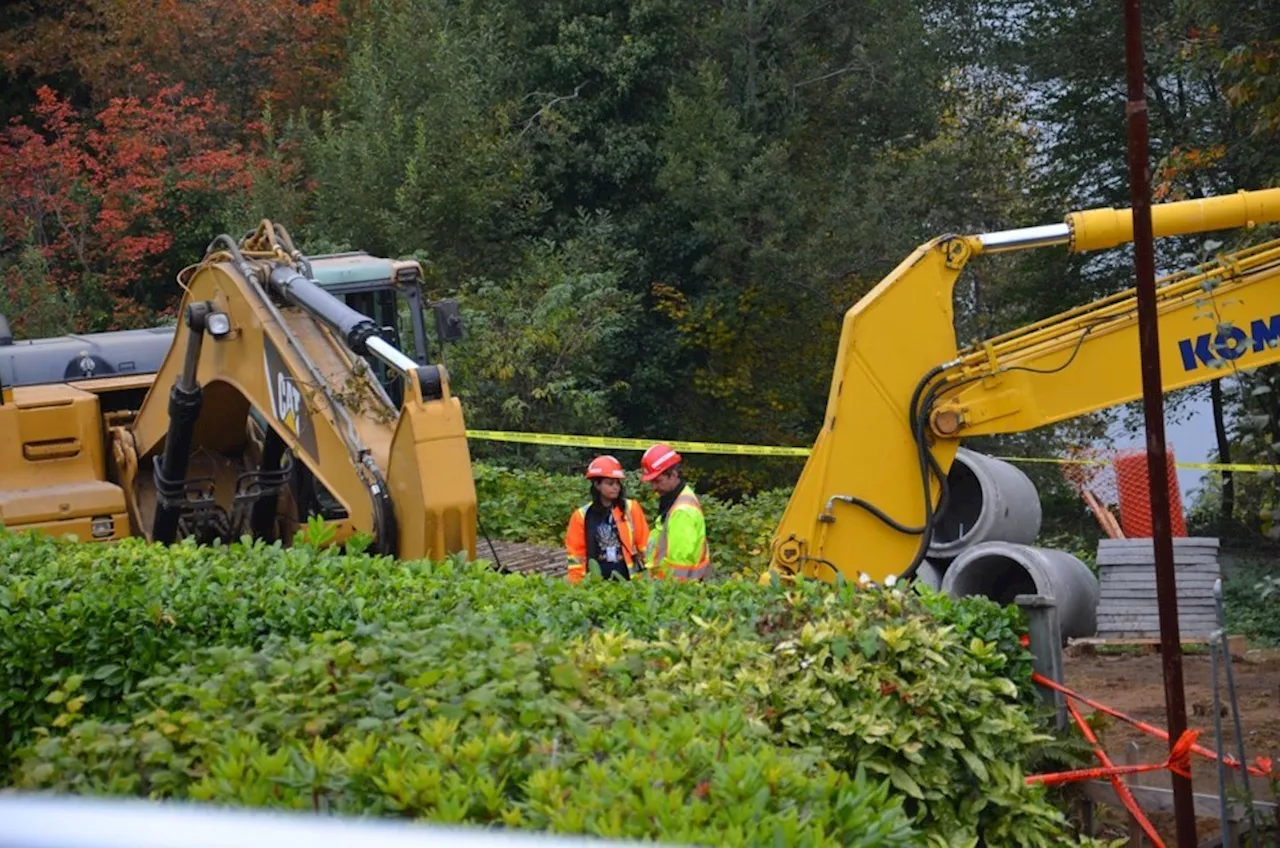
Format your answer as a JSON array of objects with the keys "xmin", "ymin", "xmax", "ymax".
[{"xmin": 297, "ymin": 0, "xmax": 529, "ymax": 291}]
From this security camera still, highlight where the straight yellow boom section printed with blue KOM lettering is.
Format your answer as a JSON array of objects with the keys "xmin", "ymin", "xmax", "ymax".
[{"xmin": 931, "ymin": 241, "xmax": 1280, "ymax": 438}]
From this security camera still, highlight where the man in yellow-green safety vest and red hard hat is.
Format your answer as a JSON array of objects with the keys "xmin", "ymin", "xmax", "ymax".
[{"xmin": 640, "ymin": 443, "xmax": 712, "ymax": 580}]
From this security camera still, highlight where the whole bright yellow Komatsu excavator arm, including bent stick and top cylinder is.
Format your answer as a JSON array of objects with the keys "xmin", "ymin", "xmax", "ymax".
[{"xmin": 772, "ymin": 188, "xmax": 1280, "ymax": 583}]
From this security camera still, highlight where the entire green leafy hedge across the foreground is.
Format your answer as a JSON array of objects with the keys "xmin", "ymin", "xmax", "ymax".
[{"xmin": 0, "ymin": 532, "xmax": 1111, "ymax": 845}]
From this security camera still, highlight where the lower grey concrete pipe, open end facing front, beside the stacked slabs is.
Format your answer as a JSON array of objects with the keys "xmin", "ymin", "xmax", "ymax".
[{"xmin": 942, "ymin": 542, "xmax": 1100, "ymax": 638}]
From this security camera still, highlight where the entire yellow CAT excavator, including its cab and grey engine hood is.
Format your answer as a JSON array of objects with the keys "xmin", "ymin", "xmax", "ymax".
[{"xmin": 0, "ymin": 220, "xmax": 476, "ymax": 559}]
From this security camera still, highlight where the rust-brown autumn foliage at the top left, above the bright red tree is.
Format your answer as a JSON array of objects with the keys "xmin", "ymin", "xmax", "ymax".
[{"xmin": 0, "ymin": 0, "xmax": 364, "ymax": 124}]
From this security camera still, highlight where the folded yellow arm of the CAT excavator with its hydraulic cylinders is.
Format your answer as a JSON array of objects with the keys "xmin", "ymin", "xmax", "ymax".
[{"xmin": 110, "ymin": 222, "xmax": 476, "ymax": 559}]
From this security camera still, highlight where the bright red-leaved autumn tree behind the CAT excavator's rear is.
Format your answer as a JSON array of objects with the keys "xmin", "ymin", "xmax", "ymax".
[{"xmin": 0, "ymin": 86, "xmax": 277, "ymax": 328}]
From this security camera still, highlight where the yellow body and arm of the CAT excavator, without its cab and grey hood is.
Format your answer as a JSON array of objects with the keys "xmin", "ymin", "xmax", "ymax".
[{"xmin": 0, "ymin": 222, "xmax": 476, "ymax": 559}]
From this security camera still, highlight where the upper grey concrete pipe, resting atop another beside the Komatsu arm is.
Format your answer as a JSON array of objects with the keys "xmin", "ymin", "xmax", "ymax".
[{"xmin": 928, "ymin": 447, "xmax": 1041, "ymax": 561}]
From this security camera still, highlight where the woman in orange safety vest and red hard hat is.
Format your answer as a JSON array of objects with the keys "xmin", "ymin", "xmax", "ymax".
[{"xmin": 564, "ymin": 456, "xmax": 649, "ymax": 583}]
